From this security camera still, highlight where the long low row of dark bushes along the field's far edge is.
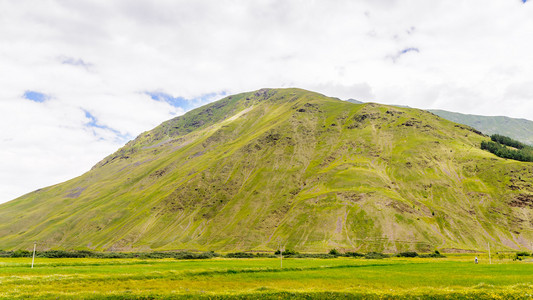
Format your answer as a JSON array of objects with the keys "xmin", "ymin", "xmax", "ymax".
[{"xmin": 0, "ymin": 249, "xmax": 445, "ymax": 259}]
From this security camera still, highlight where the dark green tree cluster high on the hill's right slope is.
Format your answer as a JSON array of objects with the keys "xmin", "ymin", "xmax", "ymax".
[{"xmin": 481, "ymin": 134, "xmax": 533, "ymax": 162}]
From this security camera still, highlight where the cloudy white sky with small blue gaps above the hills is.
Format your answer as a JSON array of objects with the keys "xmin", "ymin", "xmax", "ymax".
[{"xmin": 0, "ymin": 0, "xmax": 533, "ymax": 203}]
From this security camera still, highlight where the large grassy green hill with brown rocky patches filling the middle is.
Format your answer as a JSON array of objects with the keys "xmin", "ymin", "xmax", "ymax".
[{"xmin": 0, "ymin": 89, "xmax": 533, "ymax": 252}]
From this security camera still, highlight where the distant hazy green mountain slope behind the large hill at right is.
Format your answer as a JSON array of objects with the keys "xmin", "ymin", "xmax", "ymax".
[{"xmin": 429, "ymin": 109, "xmax": 533, "ymax": 145}]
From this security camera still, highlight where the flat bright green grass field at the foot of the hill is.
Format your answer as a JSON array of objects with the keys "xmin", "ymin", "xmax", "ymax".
[{"xmin": 0, "ymin": 254, "xmax": 533, "ymax": 299}]
